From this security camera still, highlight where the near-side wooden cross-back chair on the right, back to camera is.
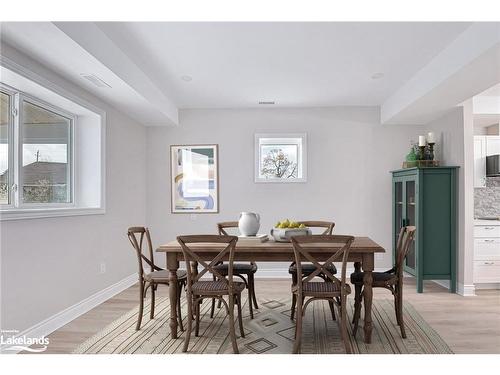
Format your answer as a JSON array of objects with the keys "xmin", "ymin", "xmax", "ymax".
[{"xmin": 292, "ymin": 235, "xmax": 354, "ymax": 354}]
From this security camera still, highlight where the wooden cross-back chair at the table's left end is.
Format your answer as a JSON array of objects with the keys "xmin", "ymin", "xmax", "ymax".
[{"xmin": 127, "ymin": 227, "xmax": 187, "ymax": 331}]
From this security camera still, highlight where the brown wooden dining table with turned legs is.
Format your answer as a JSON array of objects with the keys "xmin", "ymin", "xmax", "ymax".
[{"xmin": 156, "ymin": 237, "xmax": 385, "ymax": 344}]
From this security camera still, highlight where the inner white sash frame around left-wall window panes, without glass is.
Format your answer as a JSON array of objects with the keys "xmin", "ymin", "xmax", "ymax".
[{"xmin": 0, "ymin": 84, "xmax": 77, "ymax": 211}]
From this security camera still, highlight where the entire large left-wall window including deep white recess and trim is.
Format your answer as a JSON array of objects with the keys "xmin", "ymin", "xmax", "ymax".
[{"xmin": 0, "ymin": 59, "xmax": 106, "ymax": 221}]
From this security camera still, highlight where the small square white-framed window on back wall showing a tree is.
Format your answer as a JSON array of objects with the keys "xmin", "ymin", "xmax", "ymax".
[{"xmin": 255, "ymin": 133, "xmax": 307, "ymax": 182}]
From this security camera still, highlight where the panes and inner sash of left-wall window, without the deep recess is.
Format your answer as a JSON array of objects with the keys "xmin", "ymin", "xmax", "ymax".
[{"xmin": 0, "ymin": 86, "xmax": 76, "ymax": 208}]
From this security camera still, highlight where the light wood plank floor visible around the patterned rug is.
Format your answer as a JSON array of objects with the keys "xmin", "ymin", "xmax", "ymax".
[{"xmin": 33, "ymin": 279, "xmax": 500, "ymax": 353}]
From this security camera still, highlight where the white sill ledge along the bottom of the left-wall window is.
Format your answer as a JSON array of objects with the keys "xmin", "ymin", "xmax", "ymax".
[{"xmin": 0, "ymin": 207, "xmax": 106, "ymax": 221}]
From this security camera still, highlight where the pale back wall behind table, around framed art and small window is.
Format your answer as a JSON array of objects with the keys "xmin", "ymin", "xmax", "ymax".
[{"xmin": 147, "ymin": 107, "xmax": 421, "ymax": 276}]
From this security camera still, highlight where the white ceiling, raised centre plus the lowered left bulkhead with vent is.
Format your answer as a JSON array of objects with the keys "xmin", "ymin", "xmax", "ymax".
[{"xmin": 1, "ymin": 22, "xmax": 496, "ymax": 125}]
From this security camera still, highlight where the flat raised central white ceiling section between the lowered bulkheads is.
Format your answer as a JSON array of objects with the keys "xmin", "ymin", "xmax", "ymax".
[{"xmin": 98, "ymin": 22, "xmax": 468, "ymax": 108}]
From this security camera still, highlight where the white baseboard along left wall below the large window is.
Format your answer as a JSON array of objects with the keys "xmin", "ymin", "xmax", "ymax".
[{"xmin": 0, "ymin": 273, "xmax": 138, "ymax": 353}]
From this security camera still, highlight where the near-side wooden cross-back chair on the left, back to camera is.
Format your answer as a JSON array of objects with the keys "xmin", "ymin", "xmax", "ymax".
[{"xmin": 177, "ymin": 235, "xmax": 245, "ymax": 353}]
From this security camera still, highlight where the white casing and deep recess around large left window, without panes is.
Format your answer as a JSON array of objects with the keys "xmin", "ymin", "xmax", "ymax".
[{"xmin": 0, "ymin": 55, "xmax": 107, "ymax": 222}]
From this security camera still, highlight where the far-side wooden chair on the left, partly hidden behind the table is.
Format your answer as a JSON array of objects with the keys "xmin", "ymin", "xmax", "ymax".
[{"xmin": 210, "ymin": 221, "xmax": 259, "ymax": 319}]
